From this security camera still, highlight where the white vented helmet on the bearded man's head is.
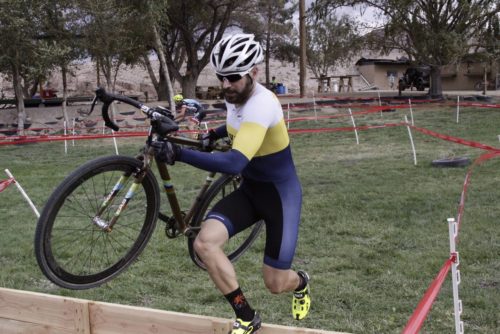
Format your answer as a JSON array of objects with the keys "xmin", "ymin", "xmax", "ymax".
[{"xmin": 210, "ymin": 34, "xmax": 264, "ymax": 74}]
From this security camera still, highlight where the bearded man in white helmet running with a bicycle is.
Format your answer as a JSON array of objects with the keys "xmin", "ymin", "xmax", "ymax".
[{"xmin": 155, "ymin": 34, "xmax": 311, "ymax": 334}]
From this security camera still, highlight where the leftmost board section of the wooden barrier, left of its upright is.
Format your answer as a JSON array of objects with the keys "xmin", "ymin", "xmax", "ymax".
[{"xmin": 0, "ymin": 288, "xmax": 90, "ymax": 334}]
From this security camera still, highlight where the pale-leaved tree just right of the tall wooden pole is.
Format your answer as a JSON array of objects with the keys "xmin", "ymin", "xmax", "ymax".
[{"xmin": 307, "ymin": 6, "xmax": 363, "ymax": 78}]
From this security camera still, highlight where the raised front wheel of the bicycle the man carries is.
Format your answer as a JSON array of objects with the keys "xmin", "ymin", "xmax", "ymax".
[{"xmin": 35, "ymin": 156, "xmax": 160, "ymax": 290}]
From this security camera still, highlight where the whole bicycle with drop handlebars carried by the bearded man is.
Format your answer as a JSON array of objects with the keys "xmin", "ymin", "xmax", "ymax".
[{"xmin": 35, "ymin": 88, "xmax": 263, "ymax": 290}]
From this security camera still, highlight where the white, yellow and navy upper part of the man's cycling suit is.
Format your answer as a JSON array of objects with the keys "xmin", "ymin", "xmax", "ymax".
[{"xmin": 179, "ymin": 83, "xmax": 295, "ymax": 181}]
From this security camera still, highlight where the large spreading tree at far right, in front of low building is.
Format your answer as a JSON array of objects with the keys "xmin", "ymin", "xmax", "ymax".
[{"xmin": 317, "ymin": 0, "xmax": 500, "ymax": 96}]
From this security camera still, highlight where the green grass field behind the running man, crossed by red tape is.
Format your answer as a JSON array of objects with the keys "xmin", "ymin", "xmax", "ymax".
[{"xmin": 0, "ymin": 102, "xmax": 500, "ymax": 333}]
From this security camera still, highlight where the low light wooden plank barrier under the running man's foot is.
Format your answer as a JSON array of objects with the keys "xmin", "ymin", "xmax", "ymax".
[{"xmin": 0, "ymin": 288, "xmax": 348, "ymax": 334}]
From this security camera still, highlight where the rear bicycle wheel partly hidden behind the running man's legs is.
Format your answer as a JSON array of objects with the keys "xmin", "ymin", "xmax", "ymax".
[{"xmin": 188, "ymin": 175, "xmax": 264, "ymax": 270}]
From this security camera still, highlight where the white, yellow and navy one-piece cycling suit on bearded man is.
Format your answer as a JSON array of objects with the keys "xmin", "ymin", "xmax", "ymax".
[{"xmin": 179, "ymin": 83, "xmax": 302, "ymax": 269}]
